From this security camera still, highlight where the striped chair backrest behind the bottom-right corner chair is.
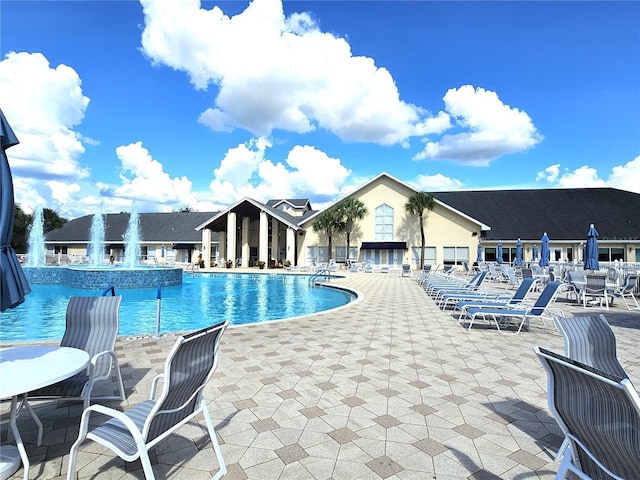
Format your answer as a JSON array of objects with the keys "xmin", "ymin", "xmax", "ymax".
[{"xmin": 553, "ymin": 315, "xmax": 629, "ymax": 378}]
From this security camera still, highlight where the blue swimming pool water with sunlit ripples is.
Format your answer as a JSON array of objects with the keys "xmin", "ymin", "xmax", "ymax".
[{"xmin": 0, "ymin": 274, "xmax": 355, "ymax": 343}]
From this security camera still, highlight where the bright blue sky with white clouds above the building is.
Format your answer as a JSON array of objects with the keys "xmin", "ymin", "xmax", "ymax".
[{"xmin": 0, "ymin": 0, "xmax": 640, "ymax": 218}]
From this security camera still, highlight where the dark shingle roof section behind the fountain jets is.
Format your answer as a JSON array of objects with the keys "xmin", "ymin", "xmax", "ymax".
[{"xmin": 45, "ymin": 212, "xmax": 216, "ymax": 243}]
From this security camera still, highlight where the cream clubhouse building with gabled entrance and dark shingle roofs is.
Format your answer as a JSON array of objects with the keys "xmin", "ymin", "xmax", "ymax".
[{"xmin": 46, "ymin": 172, "xmax": 640, "ymax": 267}]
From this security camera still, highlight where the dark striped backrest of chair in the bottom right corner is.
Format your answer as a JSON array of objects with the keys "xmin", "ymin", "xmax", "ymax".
[{"xmin": 534, "ymin": 346, "xmax": 640, "ymax": 479}]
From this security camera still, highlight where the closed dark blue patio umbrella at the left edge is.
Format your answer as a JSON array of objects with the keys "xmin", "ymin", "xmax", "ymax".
[{"xmin": 0, "ymin": 109, "xmax": 31, "ymax": 312}]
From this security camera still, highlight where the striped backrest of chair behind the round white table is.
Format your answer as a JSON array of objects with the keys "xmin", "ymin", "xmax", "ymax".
[{"xmin": 60, "ymin": 295, "xmax": 122, "ymax": 377}]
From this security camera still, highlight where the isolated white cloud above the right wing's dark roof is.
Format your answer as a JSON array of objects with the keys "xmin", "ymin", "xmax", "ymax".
[{"xmin": 414, "ymin": 85, "xmax": 542, "ymax": 166}]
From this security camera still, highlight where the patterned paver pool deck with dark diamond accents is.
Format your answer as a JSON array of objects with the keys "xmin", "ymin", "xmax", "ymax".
[{"xmin": 2, "ymin": 271, "xmax": 640, "ymax": 480}]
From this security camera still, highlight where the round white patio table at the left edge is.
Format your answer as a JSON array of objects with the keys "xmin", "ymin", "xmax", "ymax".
[{"xmin": 0, "ymin": 346, "xmax": 89, "ymax": 480}]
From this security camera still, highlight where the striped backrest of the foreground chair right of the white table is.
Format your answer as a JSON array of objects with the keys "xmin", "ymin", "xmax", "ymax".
[{"xmin": 142, "ymin": 321, "xmax": 229, "ymax": 442}]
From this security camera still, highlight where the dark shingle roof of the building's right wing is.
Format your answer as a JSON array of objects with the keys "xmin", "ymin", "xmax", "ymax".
[{"xmin": 432, "ymin": 188, "xmax": 640, "ymax": 240}]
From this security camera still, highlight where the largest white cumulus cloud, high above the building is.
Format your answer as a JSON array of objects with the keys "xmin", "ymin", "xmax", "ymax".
[{"xmin": 141, "ymin": 0, "xmax": 450, "ymax": 145}]
